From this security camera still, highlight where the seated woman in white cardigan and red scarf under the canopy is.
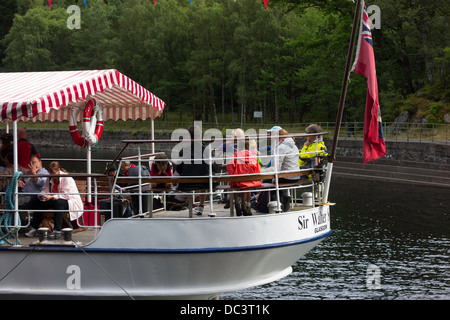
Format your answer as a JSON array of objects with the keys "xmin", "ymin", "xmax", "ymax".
[{"xmin": 25, "ymin": 161, "xmax": 83, "ymax": 239}]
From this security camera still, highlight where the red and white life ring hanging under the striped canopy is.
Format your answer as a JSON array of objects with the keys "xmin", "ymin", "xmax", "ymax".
[{"xmin": 69, "ymin": 98, "xmax": 103, "ymax": 148}]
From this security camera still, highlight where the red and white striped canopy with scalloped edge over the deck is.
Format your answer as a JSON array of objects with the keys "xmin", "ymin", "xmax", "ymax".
[{"xmin": 0, "ymin": 69, "xmax": 165, "ymax": 122}]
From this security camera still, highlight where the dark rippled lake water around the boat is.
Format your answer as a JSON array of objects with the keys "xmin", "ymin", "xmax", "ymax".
[{"xmin": 40, "ymin": 149, "xmax": 450, "ymax": 300}]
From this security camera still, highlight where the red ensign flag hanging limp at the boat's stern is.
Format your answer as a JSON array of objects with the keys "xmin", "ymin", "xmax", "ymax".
[{"xmin": 352, "ymin": 0, "xmax": 386, "ymax": 163}]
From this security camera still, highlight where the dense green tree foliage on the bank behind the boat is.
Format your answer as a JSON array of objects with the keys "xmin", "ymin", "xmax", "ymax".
[{"xmin": 0, "ymin": 0, "xmax": 450, "ymax": 125}]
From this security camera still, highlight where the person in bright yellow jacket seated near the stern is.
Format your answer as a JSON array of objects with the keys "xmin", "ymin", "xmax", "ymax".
[{"xmin": 298, "ymin": 124, "xmax": 328, "ymax": 179}]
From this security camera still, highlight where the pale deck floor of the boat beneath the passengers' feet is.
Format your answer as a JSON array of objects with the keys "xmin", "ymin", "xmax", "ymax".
[{"xmin": 0, "ymin": 203, "xmax": 311, "ymax": 247}]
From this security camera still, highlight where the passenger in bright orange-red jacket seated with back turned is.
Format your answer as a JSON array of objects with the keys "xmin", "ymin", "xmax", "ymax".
[{"xmin": 227, "ymin": 139, "xmax": 261, "ymax": 216}]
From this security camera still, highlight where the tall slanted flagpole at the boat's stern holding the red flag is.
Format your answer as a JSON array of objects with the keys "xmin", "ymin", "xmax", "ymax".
[{"xmin": 323, "ymin": 0, "xmax": 363, "ymax": 203}]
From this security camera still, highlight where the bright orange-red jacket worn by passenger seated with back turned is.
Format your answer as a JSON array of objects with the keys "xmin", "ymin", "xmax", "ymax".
[{"xmin": 227, "ymin": 150, "xmax": 261, "ymax": 188}]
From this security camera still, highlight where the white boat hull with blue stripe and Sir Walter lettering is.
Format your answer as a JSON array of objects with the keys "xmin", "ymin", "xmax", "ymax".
[{"xmin": 0, "ymin": 206, "xmax": 331, "ymax": 299}]
